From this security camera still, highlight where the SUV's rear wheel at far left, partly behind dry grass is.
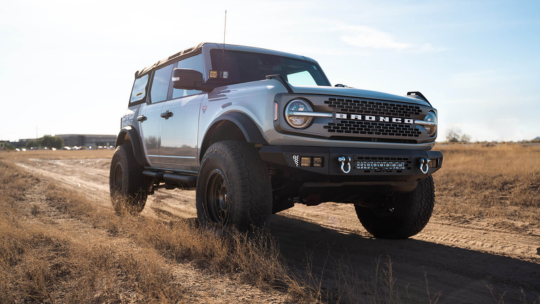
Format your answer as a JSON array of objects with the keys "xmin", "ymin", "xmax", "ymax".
[{"xmin": 109, "ymin": 145, "xmax": 150, "ymax": 214}]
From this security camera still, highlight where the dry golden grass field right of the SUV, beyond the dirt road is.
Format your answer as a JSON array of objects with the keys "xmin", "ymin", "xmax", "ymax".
[{"xmin": 434, "ymin": 144, "xmax": 540, "ymax": 228}]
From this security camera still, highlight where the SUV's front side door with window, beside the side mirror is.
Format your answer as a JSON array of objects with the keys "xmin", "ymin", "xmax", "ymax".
[{"xmin": 160, "ymin": 55, "xmax": 205, "ymax": 172}]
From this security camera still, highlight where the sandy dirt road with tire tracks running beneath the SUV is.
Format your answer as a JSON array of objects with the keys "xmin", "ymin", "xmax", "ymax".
[{"xmin": 13, "ymin": 159, "xmax": 540, "ymax": 303}]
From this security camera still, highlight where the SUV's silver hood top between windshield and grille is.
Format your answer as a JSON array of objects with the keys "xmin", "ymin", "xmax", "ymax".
[{"xmin": 291, "ymin": 86, "xmax": 430, "ymax": 106}]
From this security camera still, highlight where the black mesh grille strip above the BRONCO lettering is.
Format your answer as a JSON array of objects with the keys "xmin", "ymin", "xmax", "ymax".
[{"xmin": 324, "ymin": 98, "xmax": 422, "ymax": 117}]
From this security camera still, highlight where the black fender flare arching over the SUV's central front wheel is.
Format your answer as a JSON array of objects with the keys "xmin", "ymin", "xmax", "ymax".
[{"xmin": 199, "ymin": 112, "xmax": 268, "ymax": 159}]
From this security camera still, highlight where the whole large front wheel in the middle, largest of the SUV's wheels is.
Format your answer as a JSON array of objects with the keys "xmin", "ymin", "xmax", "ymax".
[{"xmin": 196, "ymin": 141, "xmax": 272, "ymax": 231}]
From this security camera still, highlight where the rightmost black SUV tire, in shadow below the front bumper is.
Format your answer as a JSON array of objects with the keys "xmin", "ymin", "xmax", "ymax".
[{"xmin": 355, "ymin": 176, "xmax": 435, "ymax": 239}]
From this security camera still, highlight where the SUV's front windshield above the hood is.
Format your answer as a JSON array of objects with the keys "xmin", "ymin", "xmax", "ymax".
[{"xmin": 210, "ymin": 49, "xmax": 330, "ymax": 86}]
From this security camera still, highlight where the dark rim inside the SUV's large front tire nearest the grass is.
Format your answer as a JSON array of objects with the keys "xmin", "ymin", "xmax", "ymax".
[{"xmin": 206, "ymin": 169, "xmax": 230, "ymax": 226}]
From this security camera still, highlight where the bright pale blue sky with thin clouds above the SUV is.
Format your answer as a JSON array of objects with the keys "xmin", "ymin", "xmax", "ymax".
[{"xmin": 0, "ymin": 0, "xmax": 540, "ymax": 141}]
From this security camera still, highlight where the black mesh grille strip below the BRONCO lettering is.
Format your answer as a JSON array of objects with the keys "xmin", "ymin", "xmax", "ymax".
[{"xmin": 323, "ymin": 120, "xmax": 421, "ymax": 137}]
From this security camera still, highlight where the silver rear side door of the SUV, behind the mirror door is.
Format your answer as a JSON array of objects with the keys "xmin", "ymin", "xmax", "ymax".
[{"xmin": 138, "ymin": 64, "xmax": 173, "ymax": 167}]
